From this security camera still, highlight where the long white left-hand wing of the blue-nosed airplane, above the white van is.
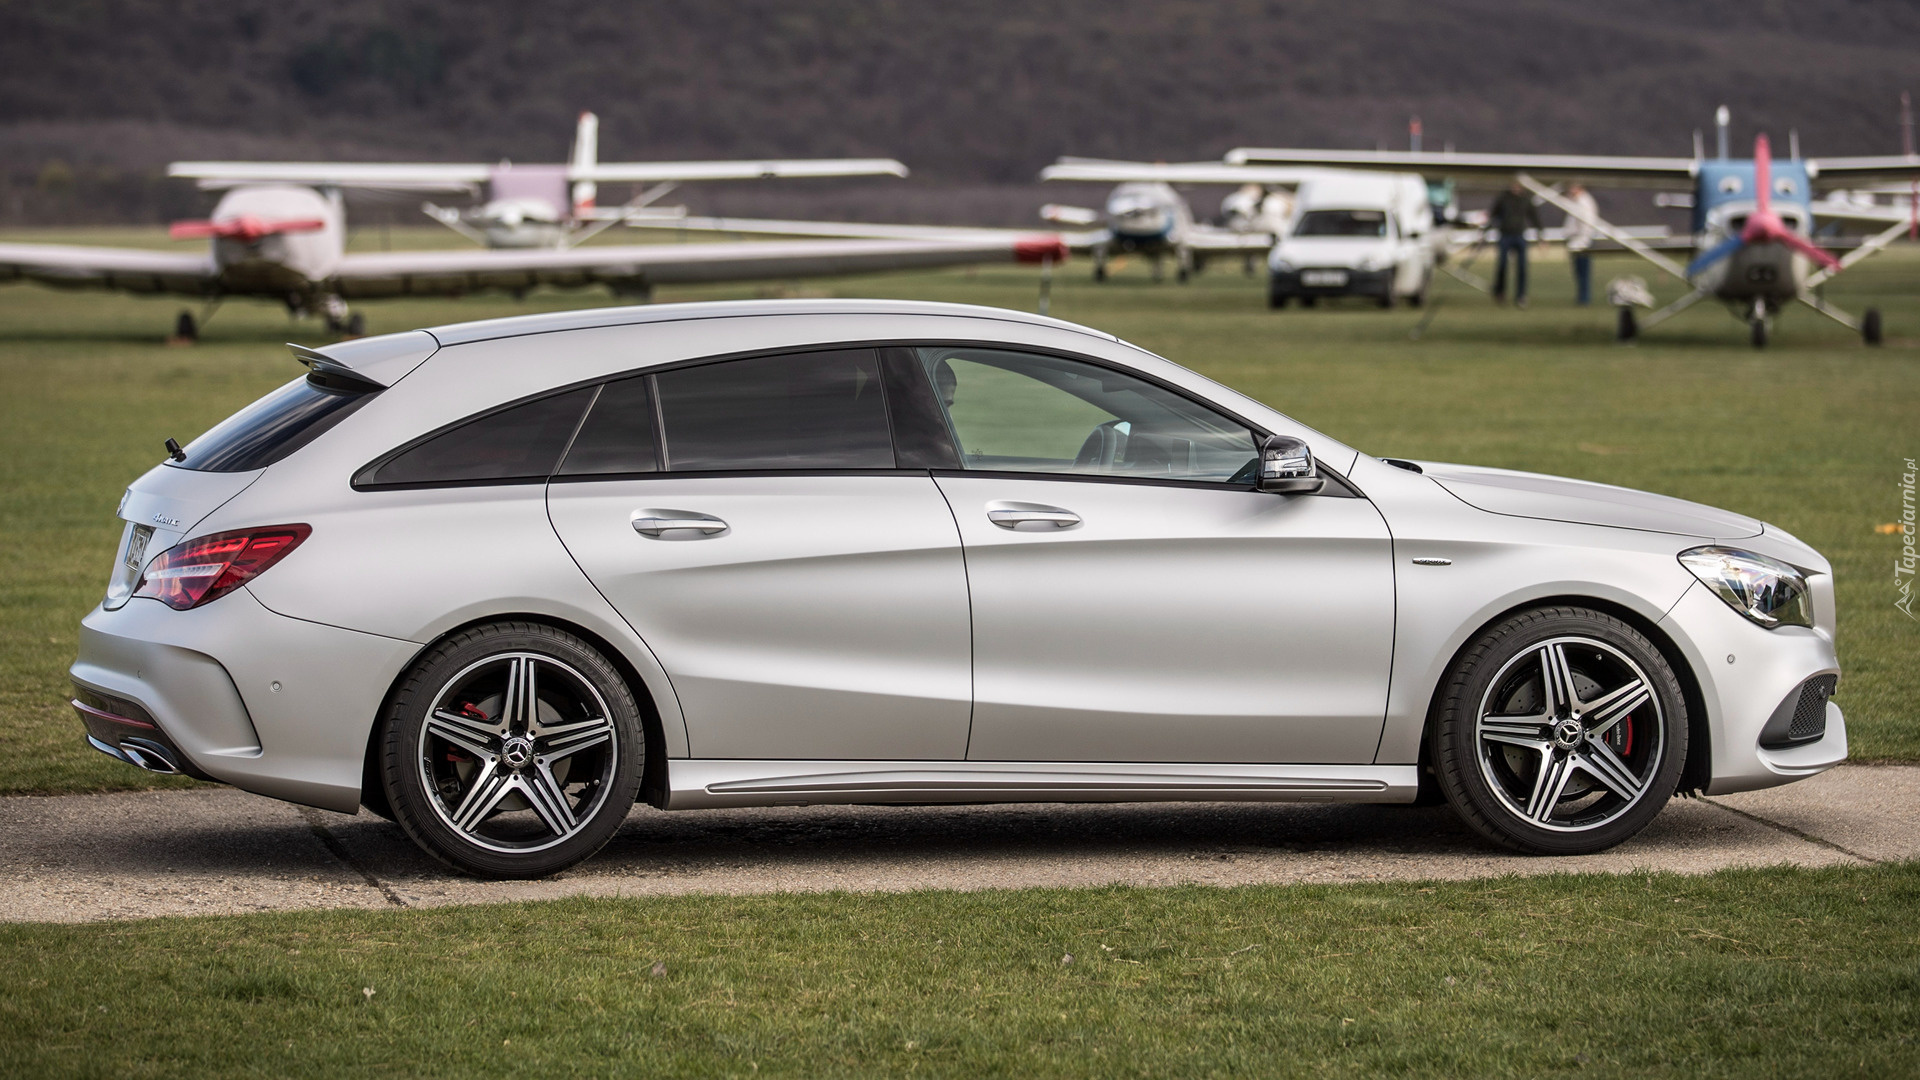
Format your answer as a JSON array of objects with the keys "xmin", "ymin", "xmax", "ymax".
[{"xmin": 1227, "ymin": 146, "xmax": 1693, "ymax": 188}]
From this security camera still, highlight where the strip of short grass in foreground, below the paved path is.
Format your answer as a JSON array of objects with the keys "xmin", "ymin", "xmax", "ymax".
[{"xmin": 0, "ymin": 865, "xmax": 1920, "ymax": 1078}]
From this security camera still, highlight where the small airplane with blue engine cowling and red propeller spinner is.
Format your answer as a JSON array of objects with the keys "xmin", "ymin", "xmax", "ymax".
[{"xmin": 1227, "ymin": 106, "xmax": 1920, "ymax": 348}]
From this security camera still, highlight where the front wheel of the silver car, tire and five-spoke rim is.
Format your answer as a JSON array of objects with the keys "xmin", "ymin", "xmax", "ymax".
[{"xmin": 1428, "ymin": 607, "xmax": 1688, "ymax": 855}]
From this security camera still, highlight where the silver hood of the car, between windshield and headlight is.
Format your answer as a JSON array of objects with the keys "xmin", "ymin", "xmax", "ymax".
[{"xmin": 1419, "ymin": 461, "xmax": 1764, "ymax": 540}]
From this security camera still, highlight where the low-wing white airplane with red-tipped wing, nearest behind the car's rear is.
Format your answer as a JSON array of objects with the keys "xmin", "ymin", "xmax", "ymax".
[{"xmin": 0, "ymin": 184, "xmax": 1066, "ymax": 340}]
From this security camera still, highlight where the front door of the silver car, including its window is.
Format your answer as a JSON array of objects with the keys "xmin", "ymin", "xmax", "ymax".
[{"xmin": 916, "ymin": 348, "xmax": 1394, "ymax": 763}]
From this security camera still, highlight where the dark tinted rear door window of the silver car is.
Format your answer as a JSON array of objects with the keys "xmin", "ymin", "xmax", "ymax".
[{"xmin": 653, "ymin": 350, "xmax": 895, "ymax": 473}]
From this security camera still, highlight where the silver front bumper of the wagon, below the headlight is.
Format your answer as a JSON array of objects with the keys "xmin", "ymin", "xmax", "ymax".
[{"xmin": 1663, "ymin": 582, "xmax": 1847, "ymax": 796}]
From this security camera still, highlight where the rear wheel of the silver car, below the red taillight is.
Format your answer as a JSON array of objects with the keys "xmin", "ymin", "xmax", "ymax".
[{"xmin": 376, "ymin": 623, "xmax": 647, "ymax": 878}]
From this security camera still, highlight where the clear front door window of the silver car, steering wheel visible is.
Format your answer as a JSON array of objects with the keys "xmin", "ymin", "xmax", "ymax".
[{"xmin": 920, "ymin": 348, "xmax": 1258, "ymax": 482}]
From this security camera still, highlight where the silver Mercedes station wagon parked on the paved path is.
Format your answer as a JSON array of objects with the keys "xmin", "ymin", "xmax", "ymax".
[{"xmin": 73, "ymin": 300, "xmax": 1847, "ymax": 876}]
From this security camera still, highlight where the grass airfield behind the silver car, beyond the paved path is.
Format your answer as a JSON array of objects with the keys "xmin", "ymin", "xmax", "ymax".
[{"xmin": 0, "ymin": 229, "xmax": 1920, "ymax": 792}]
